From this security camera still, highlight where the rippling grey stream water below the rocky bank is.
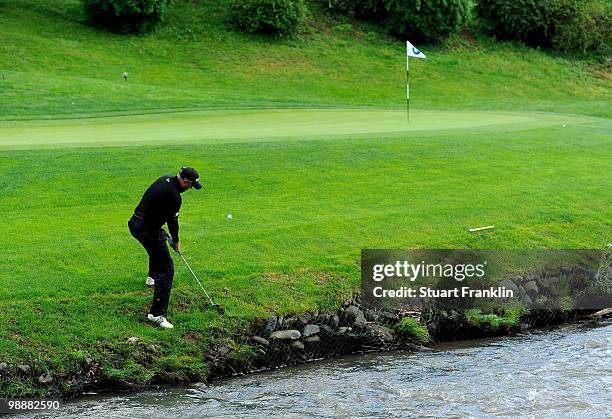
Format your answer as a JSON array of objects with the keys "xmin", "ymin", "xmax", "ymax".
[{"xmin": 25, "ymin": 321, "xmax": 612, "ymax": 418}]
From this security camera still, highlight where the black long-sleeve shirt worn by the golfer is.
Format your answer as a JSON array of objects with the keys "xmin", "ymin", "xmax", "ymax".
[{"xmin": 134, "ymin": 175, "xmax": 183, "ymax": 243}]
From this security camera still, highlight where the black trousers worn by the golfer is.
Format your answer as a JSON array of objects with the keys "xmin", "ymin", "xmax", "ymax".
[{"xmin": 128, "ymin": 216, "xmax": 174, "ymax": 316}]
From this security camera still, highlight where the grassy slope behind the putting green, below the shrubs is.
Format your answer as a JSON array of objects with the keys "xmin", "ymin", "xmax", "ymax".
[{"xmin": 0, "ymin": 0, "xmax": 611, "ymax": 119}]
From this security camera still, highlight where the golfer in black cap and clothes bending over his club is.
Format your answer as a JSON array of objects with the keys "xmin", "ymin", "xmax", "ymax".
[{"xmin": 128, "ymin": 167, "xmax": 202, "ymax": 329}]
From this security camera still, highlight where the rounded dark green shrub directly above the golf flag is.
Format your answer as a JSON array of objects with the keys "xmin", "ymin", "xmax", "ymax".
[{"xmin": 384, "ymin": 0, "xmax": 469, "ymax": 42}]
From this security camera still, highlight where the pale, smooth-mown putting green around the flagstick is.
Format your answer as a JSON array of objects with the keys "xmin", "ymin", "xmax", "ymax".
[{"xmin": 0, "ymin": 109, "xmax": 610, "ymax": 149}]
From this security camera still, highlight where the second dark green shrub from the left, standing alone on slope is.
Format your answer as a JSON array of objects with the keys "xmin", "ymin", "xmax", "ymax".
[{"xmin": 230, "ymin": 0, "xmax": 308, "ymax": 35}]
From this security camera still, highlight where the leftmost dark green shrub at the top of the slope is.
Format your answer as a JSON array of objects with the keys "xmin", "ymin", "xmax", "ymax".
[{"xmin": 82, "ymin": 0, "xmax": 171, "ymax": 33}]
